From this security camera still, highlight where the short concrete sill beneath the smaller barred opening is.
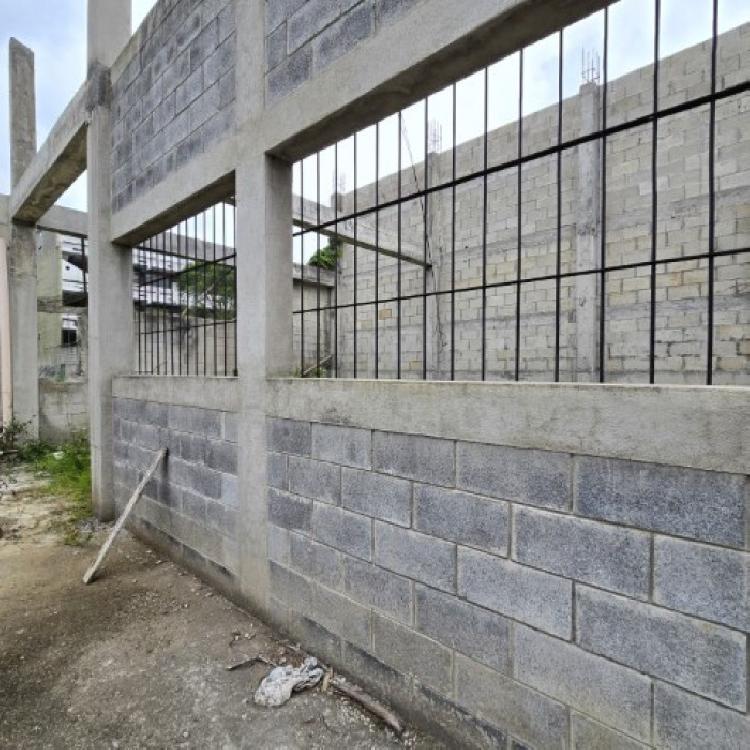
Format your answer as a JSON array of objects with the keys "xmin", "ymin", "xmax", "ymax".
[{"xmin": 112, "ymin": 375, "xmax": 240, "ymax": 412}]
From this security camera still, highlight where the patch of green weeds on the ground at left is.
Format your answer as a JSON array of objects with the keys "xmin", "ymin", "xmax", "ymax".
[{"xmin": 24, "ymin": 435, "xmax": 92, "ymax": 546}]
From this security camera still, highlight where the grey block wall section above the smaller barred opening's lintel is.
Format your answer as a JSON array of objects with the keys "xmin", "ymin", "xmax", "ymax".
[{"xmin": 112, "ymin": 0, "xmax": 236, "ymax": 212}]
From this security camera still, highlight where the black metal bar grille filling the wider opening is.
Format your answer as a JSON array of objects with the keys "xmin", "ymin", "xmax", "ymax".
[{"xmin": 293, "ymin": 0, "xmax": 750, "ymax": 384}]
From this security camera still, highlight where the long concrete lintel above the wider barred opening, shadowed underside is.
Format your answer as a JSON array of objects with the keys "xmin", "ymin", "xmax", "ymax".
[{"xmin": 258, "ymin": 0, "xmax": 610, "ymax": 161}]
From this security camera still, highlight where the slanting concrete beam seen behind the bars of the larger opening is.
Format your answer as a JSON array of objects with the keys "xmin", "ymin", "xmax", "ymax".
[{"xmin": 292, "ymin": 195, "xmax": 431, "ymax": 267}]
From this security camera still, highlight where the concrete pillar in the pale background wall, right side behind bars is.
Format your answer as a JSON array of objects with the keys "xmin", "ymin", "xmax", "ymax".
[{"xmin": 575, "ymin": 83, "xmax": 601, "ymax": 382}]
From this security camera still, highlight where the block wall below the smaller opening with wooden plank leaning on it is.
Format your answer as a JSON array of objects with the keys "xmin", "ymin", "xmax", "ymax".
[{"xmin": 113, "ymin": 378, "xmax": 239, "ymax": 591}]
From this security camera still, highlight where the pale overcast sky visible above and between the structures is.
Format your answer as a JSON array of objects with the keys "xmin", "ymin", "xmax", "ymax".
[{"xmin": 0, "ymin": 0, "xmax": 750, "ymax": 219}]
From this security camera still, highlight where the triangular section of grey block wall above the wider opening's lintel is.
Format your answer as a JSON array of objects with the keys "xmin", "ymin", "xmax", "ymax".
[{"xmin": 265, "ymin": 0, "xmax": 424, "ymax": 104}]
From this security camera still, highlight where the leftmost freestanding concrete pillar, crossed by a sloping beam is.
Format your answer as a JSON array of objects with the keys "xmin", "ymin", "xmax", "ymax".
[{"xmin": 7, "ymin": 39, "xmax": 39, "ymax": 439}]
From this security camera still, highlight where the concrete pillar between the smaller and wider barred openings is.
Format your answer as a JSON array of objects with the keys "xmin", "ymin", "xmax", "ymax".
[{"xmin": 235, "ymin": 0, "xmax": 293, "ymax": 619}]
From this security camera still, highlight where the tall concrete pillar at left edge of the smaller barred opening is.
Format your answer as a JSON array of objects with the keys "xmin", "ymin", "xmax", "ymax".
[{"xmin": 86, "ymin": 0, "xmax": 133, "ymax": 520}]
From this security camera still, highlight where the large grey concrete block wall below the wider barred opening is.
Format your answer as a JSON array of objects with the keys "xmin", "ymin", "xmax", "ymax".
[{"xmin": 266, "ymin": 381, "xmax": 750, "ymax": 750}]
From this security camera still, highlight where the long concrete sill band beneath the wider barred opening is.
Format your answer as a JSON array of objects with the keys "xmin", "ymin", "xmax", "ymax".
[{"xmin": 266, "ymin": 379, "xmax": 750, "ymax": 474}]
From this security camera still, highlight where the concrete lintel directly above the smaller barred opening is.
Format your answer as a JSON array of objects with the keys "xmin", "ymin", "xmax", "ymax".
[{"xmin": 112, "ymin": 136, "xmax": 237, "ymax": 246}]
